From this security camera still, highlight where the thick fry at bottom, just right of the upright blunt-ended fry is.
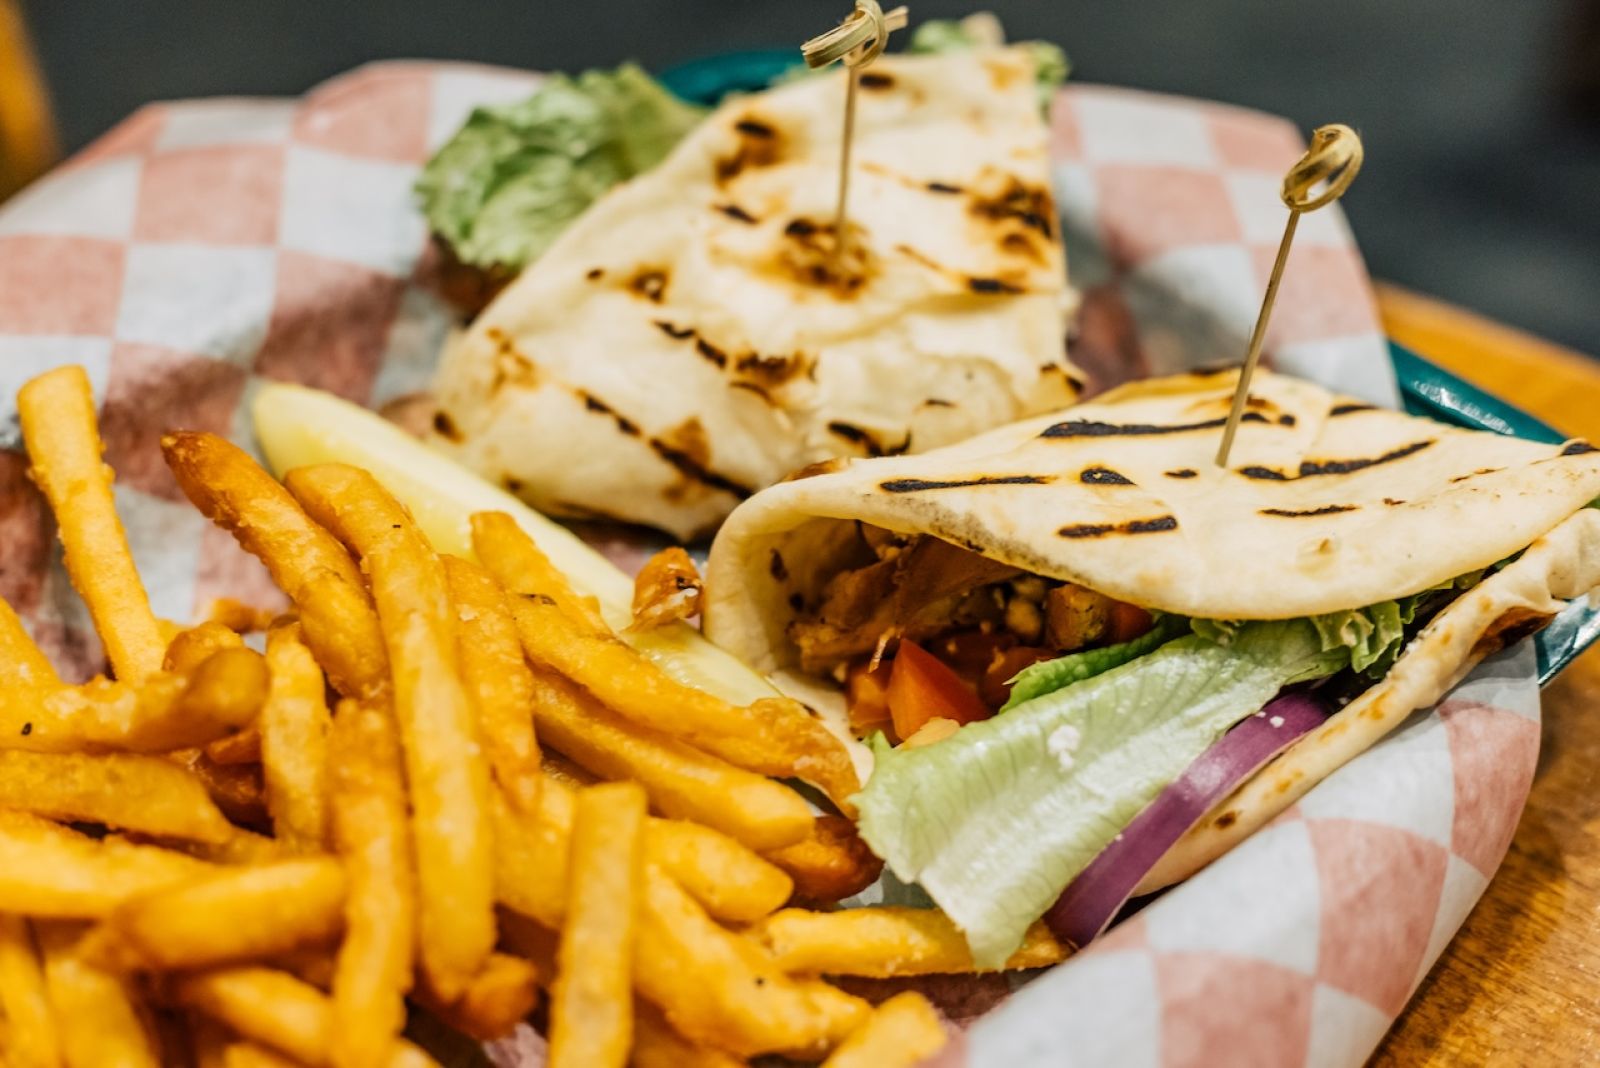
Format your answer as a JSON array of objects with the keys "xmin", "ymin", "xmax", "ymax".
[{"xmin": 634, "ymin": 865, "xmax": 869, "ymax": 1055}]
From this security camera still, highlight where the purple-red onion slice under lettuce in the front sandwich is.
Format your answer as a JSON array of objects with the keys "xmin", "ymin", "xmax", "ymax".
[{"xmin": 1045, "ymin": 692, "xmax": 1333, "ymax": 946}]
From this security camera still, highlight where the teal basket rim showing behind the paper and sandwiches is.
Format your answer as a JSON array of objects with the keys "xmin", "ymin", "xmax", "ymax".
[{"xmin": 661, "ymin": 48, "xmax": 1600, "ymax": 686}]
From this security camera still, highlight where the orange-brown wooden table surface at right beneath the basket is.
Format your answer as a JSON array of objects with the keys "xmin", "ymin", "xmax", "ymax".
[{"xmin": 1371, "ymin": 288, "xmax": 1600, "ymax": 1068}]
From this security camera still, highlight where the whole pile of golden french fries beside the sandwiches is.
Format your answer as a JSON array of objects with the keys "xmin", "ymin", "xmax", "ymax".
[{"xmin": 0, "ymin": 368, "xmax": 1064, "ymax": 1068}]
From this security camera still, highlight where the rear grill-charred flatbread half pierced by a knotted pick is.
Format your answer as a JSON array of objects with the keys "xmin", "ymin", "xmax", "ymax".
[{"xmin": 434, "ymin": 48, "xmax": 1077, "ymax": 537}]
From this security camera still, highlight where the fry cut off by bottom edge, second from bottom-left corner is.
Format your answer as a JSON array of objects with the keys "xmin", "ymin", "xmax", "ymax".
[{"xmin": 37, "ymin": 924, "xmax": 162, "ymax": 1068}]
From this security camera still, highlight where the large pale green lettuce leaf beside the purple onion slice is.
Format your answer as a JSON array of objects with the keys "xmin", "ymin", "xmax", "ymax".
[{"xmin": 854, "ymin": 620, "xmax": 1349, "ymax": 967}]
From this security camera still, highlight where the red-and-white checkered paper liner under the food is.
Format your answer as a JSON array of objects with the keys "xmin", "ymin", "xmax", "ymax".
[{"xmin": 0, "ymin": 62, "xmax": 1539, "ymax": 1068}]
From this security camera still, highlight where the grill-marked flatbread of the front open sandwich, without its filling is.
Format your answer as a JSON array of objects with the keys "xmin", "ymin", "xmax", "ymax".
[{"xmin": 706, "ymin": 373, "xmax": 1600, "ymax": 952}]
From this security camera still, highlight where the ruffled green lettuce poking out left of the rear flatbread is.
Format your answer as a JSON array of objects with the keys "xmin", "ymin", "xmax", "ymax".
[{"xmin": 416, "ymin": 64, "xmax": 706, "ymax": 270}]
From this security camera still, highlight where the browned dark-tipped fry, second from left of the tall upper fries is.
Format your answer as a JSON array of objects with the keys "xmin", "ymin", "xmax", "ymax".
[{"xmin": 162, "ymin": 432, "xmax": 389, "ymax": 695}]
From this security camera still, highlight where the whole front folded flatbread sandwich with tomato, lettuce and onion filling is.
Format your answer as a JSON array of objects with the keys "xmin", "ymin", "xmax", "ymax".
[{"xmin": 706, "ymin": 364, "xmax": 1600, "ymax": 966}]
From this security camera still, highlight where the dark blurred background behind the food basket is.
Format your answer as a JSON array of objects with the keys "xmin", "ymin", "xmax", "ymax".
[{"xmin": 0, "ymin": 0, "xmax": 1600, "ymax": 353}]
